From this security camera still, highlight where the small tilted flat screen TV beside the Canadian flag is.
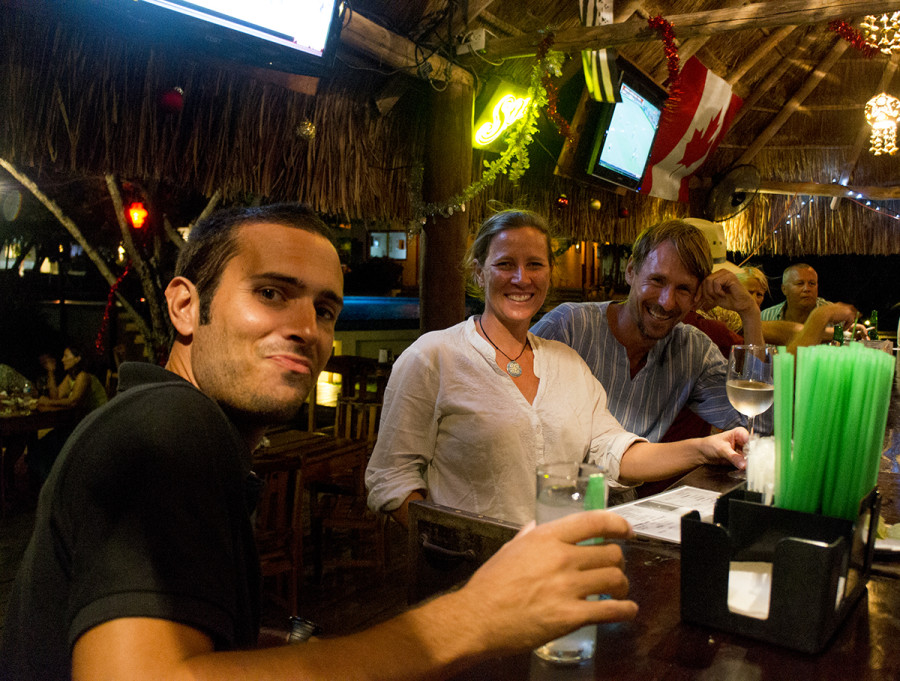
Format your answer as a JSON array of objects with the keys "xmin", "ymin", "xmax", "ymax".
[{"xmin": 586, "ymin": 57, "xmax": 666, "ymax": 190}]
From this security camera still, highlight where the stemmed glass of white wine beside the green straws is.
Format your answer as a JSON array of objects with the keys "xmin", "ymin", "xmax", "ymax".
[{"xmin": 725, "ymin": 345, "xmax": 776, "ymax": 438}]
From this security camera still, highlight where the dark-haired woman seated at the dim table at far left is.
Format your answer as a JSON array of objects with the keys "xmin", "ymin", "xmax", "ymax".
[{"xmin": 25, "ymin": 345, "xmax": 106, "ymax": 484}]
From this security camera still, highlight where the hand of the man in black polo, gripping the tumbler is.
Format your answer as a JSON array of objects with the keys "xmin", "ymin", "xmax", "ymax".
[{"xmin": 451, "ymin": 511, "xmax": 637, "ymax": 653}]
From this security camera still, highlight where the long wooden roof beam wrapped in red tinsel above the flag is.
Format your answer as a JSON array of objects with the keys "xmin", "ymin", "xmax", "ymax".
[{"xmin": 484, "ymin": 0, "xmax": 900, "ymax": 60}]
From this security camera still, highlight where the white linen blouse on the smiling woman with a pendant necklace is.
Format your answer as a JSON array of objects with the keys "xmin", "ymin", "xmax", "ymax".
[{"xmin": 366, "ymin": 317, "xmax": 643, "ymax": 524}]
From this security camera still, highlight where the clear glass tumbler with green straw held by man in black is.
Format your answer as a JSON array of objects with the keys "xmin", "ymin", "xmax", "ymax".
[{"xmin": 534, "ymin": 463, "xmax": 607, "ymax": 664}]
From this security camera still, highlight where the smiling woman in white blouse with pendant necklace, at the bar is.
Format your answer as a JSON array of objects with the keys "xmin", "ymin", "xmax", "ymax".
[{"xmin": 366, "ymin": 211, "xmax": 747, "ymax": 526}]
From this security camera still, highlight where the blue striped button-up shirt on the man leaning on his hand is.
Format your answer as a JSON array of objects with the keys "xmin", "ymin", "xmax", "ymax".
[{"xmin": 531, "ymin": 302, "xmax": 746, "ymax": 442}]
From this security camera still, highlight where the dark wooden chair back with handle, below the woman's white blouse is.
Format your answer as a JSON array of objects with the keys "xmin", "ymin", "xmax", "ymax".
[{"xmin": 407, "ymin": 501, "xmax": 519, "ymax": 605}]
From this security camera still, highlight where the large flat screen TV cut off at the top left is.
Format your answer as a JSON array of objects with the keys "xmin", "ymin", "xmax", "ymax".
[{"xmin": 69, "ymin": 0, "xmax": 343, "ymax": 76}]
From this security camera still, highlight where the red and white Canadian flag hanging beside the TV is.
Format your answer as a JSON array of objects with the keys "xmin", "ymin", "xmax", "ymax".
[{"xmin": 641, "ymin": 57, "xmax": 744, "ymax": 202}]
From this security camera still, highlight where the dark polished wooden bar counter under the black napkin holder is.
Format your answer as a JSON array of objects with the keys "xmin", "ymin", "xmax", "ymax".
[{"xmin": 444, "ymin": 452, "xmax": 900, "ymax": 681}]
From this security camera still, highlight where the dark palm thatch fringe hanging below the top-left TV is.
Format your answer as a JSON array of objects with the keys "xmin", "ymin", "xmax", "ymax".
[{"xmin": 0, "ymin": 7, "xmax": 422, "ymax": 219}]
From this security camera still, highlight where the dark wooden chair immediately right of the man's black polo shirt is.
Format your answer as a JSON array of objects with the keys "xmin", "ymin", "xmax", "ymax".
[{"xmin": 255, "ymin": 466, "xmax": 303, "ymax": 615}]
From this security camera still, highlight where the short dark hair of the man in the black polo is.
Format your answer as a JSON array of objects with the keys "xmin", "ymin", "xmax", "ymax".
[{"xmin": 175, "ymin": 203, "xmax": 334, "ymax": 324}]
